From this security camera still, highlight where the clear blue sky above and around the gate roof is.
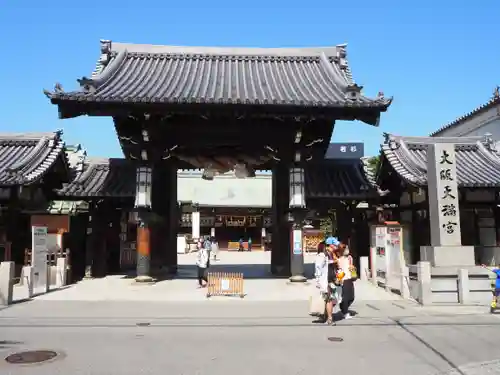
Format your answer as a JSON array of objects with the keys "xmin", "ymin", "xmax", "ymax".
[{"xmin": 0, "ymin": 0, "xmax": 500, "ymax": 157}]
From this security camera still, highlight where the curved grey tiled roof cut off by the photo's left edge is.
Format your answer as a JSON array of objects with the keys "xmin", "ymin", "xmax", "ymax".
[{"xmin": 0, "ymin": 131, "xmax": 68, "ymax": 186}]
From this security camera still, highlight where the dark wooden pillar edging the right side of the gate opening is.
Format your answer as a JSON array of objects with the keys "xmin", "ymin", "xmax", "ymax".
[{"xmin": 271, "ymin": 163, "xmax": 291, "ymax": 276}]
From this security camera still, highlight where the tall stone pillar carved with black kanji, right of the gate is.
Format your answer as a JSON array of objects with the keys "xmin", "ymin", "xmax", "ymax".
[{"xmin": 427, "ymin": 143, "xmax": 462, "ymax": 246}]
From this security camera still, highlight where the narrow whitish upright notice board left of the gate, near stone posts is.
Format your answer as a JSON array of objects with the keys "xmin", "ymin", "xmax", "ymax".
[{"xmin": 31, "ymin": 226, "xmax": 48, "ymax": 288}]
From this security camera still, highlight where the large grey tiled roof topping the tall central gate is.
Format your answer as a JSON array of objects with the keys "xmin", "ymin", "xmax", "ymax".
[{"xmin": 45, "ymin": 41, "xmax": 391, "ymax": 124}]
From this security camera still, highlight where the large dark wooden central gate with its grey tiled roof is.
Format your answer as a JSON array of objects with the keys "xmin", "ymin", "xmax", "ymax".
[{"xmin": 45, "ymin": 41, "xmax": 391, "ymax": 281}]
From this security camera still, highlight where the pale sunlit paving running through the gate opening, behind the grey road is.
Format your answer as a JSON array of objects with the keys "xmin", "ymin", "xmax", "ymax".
[{"xmin": 14, "ymin": 252, "xmax": 399, "ymax": 302}]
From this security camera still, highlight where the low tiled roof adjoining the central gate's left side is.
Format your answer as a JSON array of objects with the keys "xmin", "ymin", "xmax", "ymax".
[{"xmin": 58, "ymin": 159, "xmax": 135, "ymax": 198}]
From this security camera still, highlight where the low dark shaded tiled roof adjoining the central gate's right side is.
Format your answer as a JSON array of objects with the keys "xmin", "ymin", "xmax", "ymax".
[{"xmin": 305, "ymin": 160, "xmax": 377, "ymax": 199}]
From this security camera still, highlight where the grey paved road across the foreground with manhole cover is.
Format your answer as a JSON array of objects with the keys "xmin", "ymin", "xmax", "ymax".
[{"xmin": 0, "ymin": 300, "xmax": 500, "ymax": 375}]
